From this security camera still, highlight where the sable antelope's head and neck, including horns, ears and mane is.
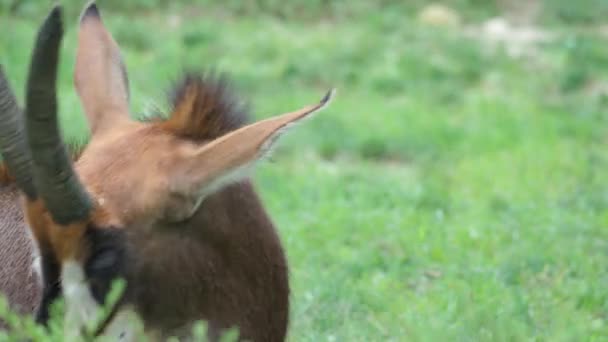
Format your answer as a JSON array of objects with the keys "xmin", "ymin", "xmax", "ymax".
[{"xmin": 0, "ymin": 3, "xmax": 333, "ymax": 341}]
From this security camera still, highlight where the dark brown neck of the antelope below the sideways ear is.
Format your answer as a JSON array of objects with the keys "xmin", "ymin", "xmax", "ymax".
[{"xmin": 123, "ymin": 181, "xmax": 289, "ymax": 341}]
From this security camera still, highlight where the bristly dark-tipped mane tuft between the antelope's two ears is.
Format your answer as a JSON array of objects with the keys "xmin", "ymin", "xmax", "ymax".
[{"xmin": 159, "ymin": 72, "xmax": 249, "ymax": 140}]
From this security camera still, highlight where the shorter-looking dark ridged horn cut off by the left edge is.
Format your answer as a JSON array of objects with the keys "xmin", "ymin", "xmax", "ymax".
[{"xmin": 0, "ymin": 65, "xmax": 37, "ymax": 201}]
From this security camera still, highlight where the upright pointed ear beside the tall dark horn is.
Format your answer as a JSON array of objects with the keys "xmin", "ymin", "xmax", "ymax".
[{"xmin": 74, "ymin": 2, "xmax": 129, "ymax": 134}]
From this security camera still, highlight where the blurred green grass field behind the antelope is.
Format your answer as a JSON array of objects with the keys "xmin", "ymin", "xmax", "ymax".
[{"xmin": 0, "ymin": 0, "xmax": 608, "ymax": 341}]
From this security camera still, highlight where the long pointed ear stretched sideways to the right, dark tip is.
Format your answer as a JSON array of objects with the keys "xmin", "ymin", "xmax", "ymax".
[{"xmin": 171, "ymin": 89, "xmax": 335, "ymax": 199}]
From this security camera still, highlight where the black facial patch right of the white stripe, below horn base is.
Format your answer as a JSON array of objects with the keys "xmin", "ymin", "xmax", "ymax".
[{"xmin": 84, "ymin": 226, "xmax": 127, "ymax": 304}]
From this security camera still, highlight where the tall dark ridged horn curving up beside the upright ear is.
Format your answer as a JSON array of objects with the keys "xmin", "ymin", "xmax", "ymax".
[{"xmin": 25, "ymin": 5, "xmax": 92, "ymax": 224}]
